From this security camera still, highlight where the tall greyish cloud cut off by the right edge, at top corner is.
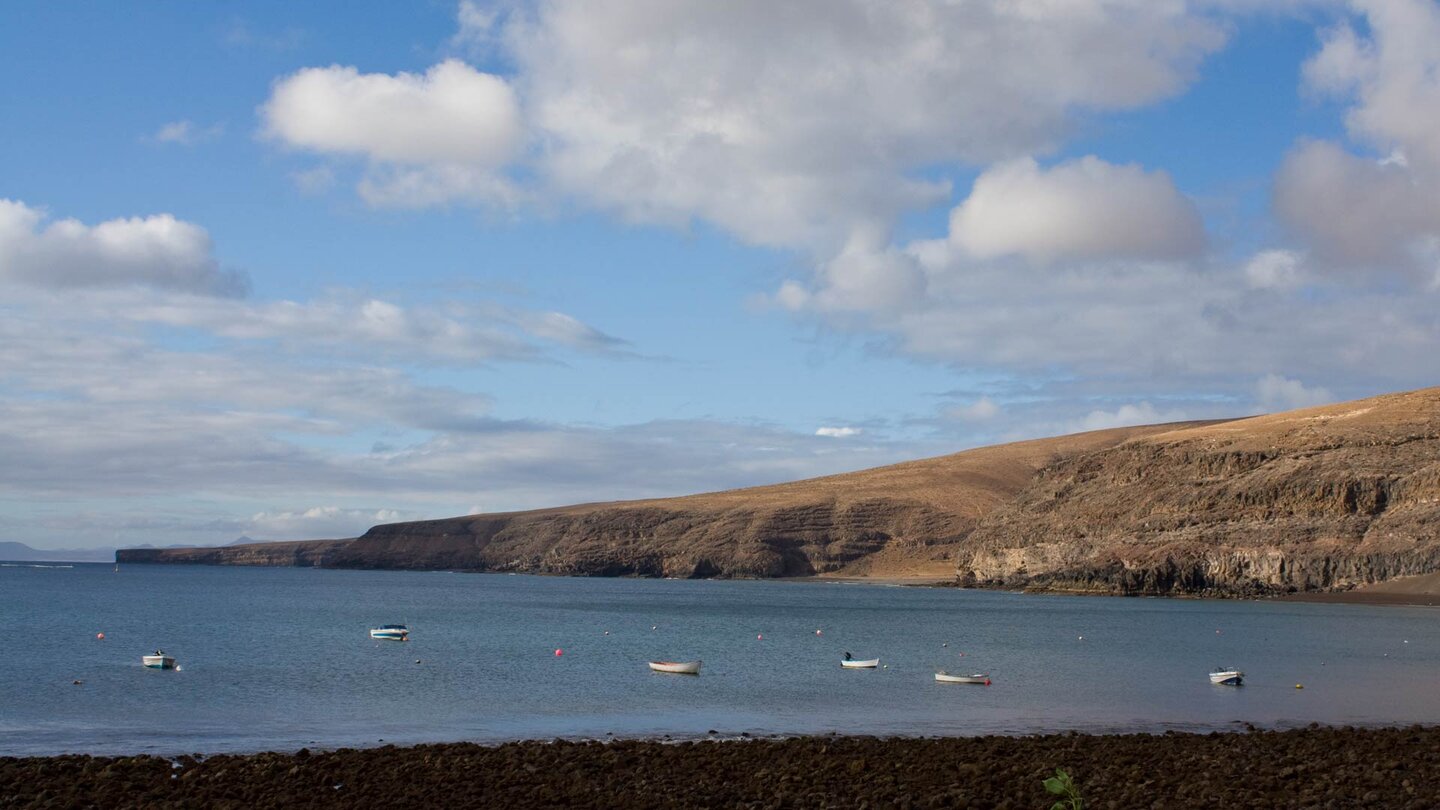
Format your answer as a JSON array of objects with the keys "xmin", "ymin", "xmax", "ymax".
[{"xmin": 1274, "ymin": 0, "xmax": 1440, "ymax": 273}]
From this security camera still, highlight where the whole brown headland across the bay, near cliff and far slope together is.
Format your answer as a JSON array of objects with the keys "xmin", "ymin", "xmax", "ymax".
[{"xmin": 118, "ymin": 380, "xmax": 1440, "ymax": 595}]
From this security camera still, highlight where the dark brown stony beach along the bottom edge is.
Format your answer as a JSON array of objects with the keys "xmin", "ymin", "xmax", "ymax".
[{"xmin": 0, "ymin": 726, "xmax": 1440, "ymax": 809}]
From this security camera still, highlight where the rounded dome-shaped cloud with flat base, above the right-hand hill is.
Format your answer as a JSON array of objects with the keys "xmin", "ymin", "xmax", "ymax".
[{"xmin": 950, "ymin": 156, "xmax": 1205, "ymax": 262}]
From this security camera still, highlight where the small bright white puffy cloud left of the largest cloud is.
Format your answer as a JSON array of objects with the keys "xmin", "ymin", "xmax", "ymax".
[{"xmin": 261, "ymin": 59, "xmax": 524, "ymax": 205}]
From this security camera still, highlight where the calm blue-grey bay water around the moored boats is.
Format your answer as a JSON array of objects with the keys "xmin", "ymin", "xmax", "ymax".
[{"xmin": 0, "ymin": 564, "xmax": 1440, "ymax": 755}]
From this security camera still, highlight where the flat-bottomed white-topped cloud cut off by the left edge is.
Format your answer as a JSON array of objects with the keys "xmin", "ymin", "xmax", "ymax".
[{"xmin": 0, "ymin": 199, "xmax": 249, "ymax": 295}]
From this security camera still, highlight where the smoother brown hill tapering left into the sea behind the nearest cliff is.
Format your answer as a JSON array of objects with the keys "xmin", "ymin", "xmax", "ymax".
[{"xmin": 118, "ymin": 422, "xmax": 1200, "ymax": 579}]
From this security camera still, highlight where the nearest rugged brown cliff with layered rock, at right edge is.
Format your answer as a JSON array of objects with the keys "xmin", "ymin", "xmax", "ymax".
[{"xmin": 958, "ymin": 389, "xmax": 1440, "ymax": 595}]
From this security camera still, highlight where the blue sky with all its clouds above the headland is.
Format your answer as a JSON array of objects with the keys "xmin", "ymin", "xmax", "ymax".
[{"xmin": 0, "ymin": 0, "xmax": 1440, "ymax": 548}]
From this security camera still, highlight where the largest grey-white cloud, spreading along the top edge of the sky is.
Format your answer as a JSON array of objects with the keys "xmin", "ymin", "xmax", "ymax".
[{"xmin": 507, "ymin": 0, "xmax": 1224, "ymax": 246}]
